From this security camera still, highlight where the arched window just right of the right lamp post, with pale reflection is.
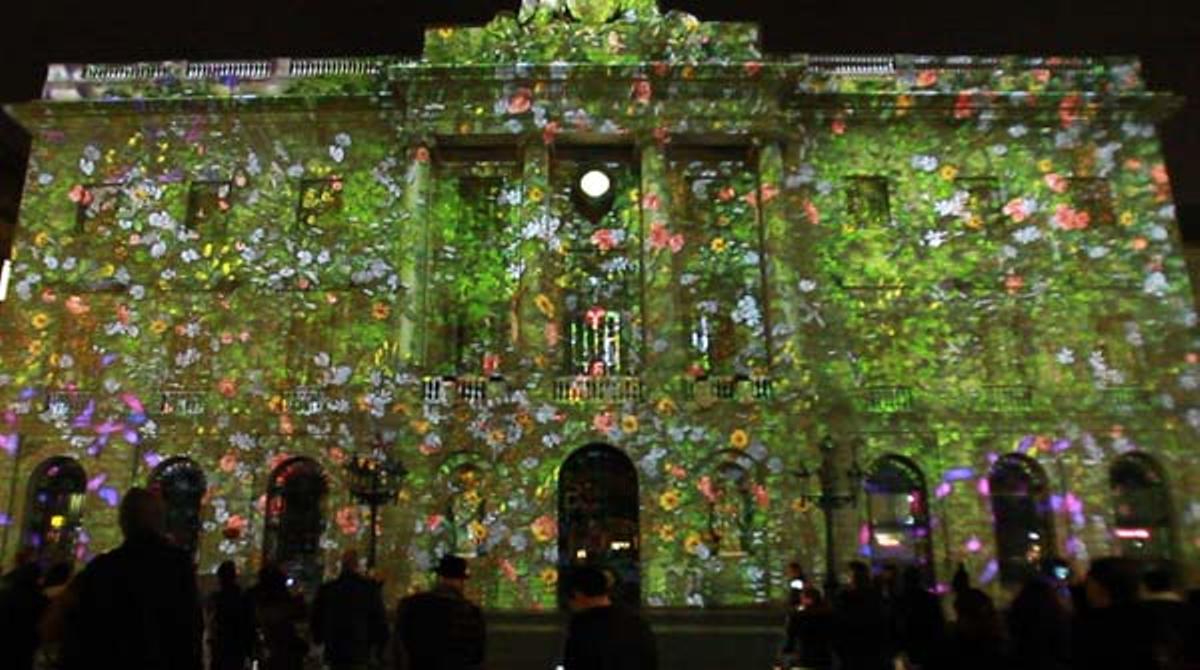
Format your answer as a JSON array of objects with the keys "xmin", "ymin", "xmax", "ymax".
[{"xmin": 863, "ymin": 454, "xmax": 934, "ymax": 580}]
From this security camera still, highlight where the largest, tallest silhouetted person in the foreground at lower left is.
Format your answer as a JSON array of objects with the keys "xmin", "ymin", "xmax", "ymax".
[{"xmin": 62, "ymin": 487, "xmax": 203, "ymax": 670}]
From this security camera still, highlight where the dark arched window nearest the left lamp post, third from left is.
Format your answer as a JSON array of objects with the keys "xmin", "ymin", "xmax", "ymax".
[{"xmin": 263, "ymin": 456, "xmax": 329, "ymax": 588}]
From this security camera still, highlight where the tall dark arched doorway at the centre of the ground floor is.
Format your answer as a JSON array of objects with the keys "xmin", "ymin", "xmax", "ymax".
[{"xmin": 558, "ymin": 444, "xmax": 642, "ymax": 606}]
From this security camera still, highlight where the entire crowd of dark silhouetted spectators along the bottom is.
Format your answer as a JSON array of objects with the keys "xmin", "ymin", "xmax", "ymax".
[{"xmin": 0, "ymin": 489, "xmax": 1200, "ymax": 670}]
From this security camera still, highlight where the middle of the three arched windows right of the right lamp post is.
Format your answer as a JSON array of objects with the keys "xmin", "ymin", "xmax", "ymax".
[{"xmin": 988, "ymin": 454, "xmax": 1056, "ymax": 584}]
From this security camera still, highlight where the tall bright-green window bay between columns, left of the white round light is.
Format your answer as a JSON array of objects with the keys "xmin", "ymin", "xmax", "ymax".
[{"xmin": 425, "ymin": 146, "xmax": 528, "ymax": 376}]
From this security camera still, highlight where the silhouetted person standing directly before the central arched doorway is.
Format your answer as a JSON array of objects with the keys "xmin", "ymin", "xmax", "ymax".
[{"xmin": 563, "ymin": 567, "xmax": 659, "ymax": 670}]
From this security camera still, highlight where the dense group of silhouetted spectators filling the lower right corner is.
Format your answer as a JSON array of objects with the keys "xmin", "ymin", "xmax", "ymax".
[{"xmin": 778, "ymin": 557, "xmax": 1200, "ymax": 670}]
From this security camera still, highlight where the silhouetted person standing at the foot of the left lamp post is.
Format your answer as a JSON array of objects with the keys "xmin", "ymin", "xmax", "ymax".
[{"xmin": 312, "ymin": 549, "xmax": 388, "ymax": 670}]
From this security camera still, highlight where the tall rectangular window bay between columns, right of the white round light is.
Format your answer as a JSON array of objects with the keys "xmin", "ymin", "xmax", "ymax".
[{"xmin": 672, "ymin": 148, "xmax": 768, "ymax": 376}]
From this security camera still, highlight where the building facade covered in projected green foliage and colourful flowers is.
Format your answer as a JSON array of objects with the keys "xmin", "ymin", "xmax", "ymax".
[{"xmin": 0, "ymin": 0, "xmax": 1200, "ymax": 609}]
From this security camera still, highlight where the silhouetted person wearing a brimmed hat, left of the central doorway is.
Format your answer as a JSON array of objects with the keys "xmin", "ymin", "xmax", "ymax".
[{"xmin": 395, "ymin": 556, "xmax": 486, "ymax": 670}]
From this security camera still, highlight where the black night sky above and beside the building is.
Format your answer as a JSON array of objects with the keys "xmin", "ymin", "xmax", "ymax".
[{"xmin": 0, "ymin": 0, "xmax": 1200, "ymax": 240}]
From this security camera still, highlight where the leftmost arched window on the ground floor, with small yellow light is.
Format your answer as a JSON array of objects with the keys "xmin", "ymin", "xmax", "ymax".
[{"xmin": 22, "ymin": 456, "xmax": 88, "ymax": 566}]
